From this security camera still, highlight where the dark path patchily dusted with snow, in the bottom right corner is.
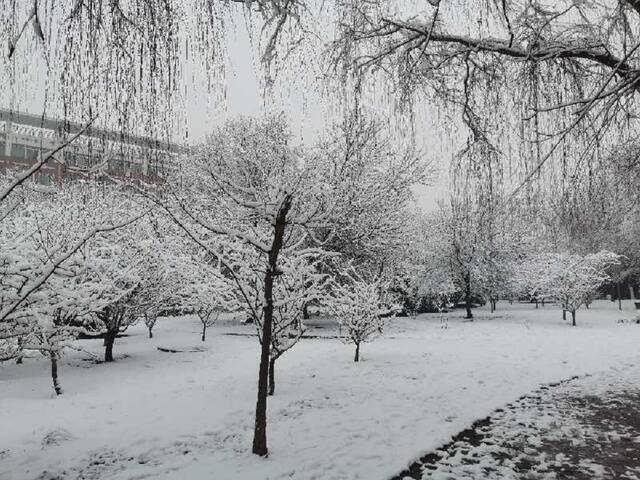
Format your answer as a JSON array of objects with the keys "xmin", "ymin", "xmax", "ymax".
[{"xmin": 394, "ymin": 365, "xmax": 640, "ymax": 480}]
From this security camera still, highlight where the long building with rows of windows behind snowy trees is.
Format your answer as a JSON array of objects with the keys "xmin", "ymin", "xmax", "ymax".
[{"xmin": 0, "ymin": 108, "xmax": 186, "ymax": 185}]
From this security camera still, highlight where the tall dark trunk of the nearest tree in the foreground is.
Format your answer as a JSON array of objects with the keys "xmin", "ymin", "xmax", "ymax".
[{"xmin": 253, "ymin": 196, "xmax": 291, "ymax": 456}]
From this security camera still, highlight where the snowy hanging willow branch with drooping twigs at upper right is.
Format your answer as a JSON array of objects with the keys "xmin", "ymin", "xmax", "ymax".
[{"xmin": 334, "ymin": 0, "xmax": 640, "ymax": 199}]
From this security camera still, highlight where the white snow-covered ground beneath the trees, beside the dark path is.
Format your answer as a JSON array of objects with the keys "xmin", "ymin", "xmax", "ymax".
[{"xmin": 0, "ymin": 301, "xmax": 640, "ymax": 480}]
